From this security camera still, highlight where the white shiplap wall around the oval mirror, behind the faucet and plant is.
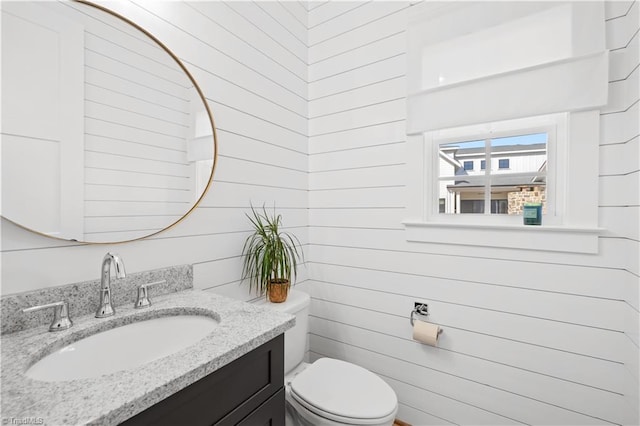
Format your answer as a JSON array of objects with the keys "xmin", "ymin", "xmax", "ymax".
[{"xmin": 2, "ymin": 1, "xmax": 308, "ymax": 299}]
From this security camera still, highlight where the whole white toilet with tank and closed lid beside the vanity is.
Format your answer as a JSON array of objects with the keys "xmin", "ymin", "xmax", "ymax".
[{"xmin": 258, "ymin": 290, "xmax": 398, "ymax": 426}]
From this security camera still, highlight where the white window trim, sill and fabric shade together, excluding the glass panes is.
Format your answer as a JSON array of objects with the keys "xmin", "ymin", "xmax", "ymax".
[{"xmin": 403, "ymin": 2, "xmax": 609, "ymax": 253}]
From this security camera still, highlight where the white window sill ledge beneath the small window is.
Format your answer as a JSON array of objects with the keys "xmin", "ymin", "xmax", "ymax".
[{"xmin": 403, "ymin": 221, "xmax": 604, "ymax": 254}]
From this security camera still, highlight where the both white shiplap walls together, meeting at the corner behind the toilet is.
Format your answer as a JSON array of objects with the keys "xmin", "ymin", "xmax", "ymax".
[{"xmin": 2, "ymin": 1, "xmax": 640, "ymax": 425}]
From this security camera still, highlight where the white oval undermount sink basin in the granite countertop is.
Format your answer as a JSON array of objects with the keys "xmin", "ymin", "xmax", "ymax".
[{"xmin": 25, "ymin": 315, "xmax": 218, "ymax": 382}]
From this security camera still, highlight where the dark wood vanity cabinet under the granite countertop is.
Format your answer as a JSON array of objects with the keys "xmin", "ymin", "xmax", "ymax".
[{"xmin": 122, "ymin": 334, "xmax": 285, "ymax": 426}]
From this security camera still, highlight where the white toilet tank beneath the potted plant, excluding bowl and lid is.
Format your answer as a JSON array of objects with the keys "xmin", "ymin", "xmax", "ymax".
[{"xmin": 256, "ymin": 290, "xmax": 311, "ymax": 374}]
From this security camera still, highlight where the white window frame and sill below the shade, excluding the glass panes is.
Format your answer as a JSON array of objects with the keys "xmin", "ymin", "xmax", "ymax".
[{"xmin": 403, "ymin": 110, "xmax": 603, "ymax": 254}]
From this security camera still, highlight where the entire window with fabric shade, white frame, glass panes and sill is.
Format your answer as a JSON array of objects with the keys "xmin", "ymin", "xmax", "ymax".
[{"xmin": 403, "ymin": 2, "xmax": 612, "ymax": 254}]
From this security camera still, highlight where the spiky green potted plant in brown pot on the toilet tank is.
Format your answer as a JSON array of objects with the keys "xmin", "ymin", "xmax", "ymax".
[{"xmin": 242, "ymin": 206, "xmax": 302, "ymax": 303}]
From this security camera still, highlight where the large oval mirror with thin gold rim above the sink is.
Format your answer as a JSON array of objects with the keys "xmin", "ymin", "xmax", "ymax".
[{"xmin": 0, "ymin": 1, "xmax": 216, "ymax": 243}]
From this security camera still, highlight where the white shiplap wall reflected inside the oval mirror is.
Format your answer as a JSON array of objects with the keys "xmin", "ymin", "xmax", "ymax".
[{"xmin": 71, "ymin": 2, "xmax": 195, "ymax": 241}]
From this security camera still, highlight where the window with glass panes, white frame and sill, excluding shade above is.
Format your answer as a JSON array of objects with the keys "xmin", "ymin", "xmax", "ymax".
[{"xmin": 403, "ymin": 111, "xmax": 601, "ymax": 253}]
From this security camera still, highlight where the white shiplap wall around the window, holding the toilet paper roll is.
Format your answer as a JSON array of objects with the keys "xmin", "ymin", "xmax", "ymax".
[{"xmin": 309, "ymin": 2, "xmax": 640, "ymax": 425}]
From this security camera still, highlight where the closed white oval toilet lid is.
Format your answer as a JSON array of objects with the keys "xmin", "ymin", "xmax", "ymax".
[{"xmin": 290, "ymin": 358, "xmax": 398, "ymax": 424}]
